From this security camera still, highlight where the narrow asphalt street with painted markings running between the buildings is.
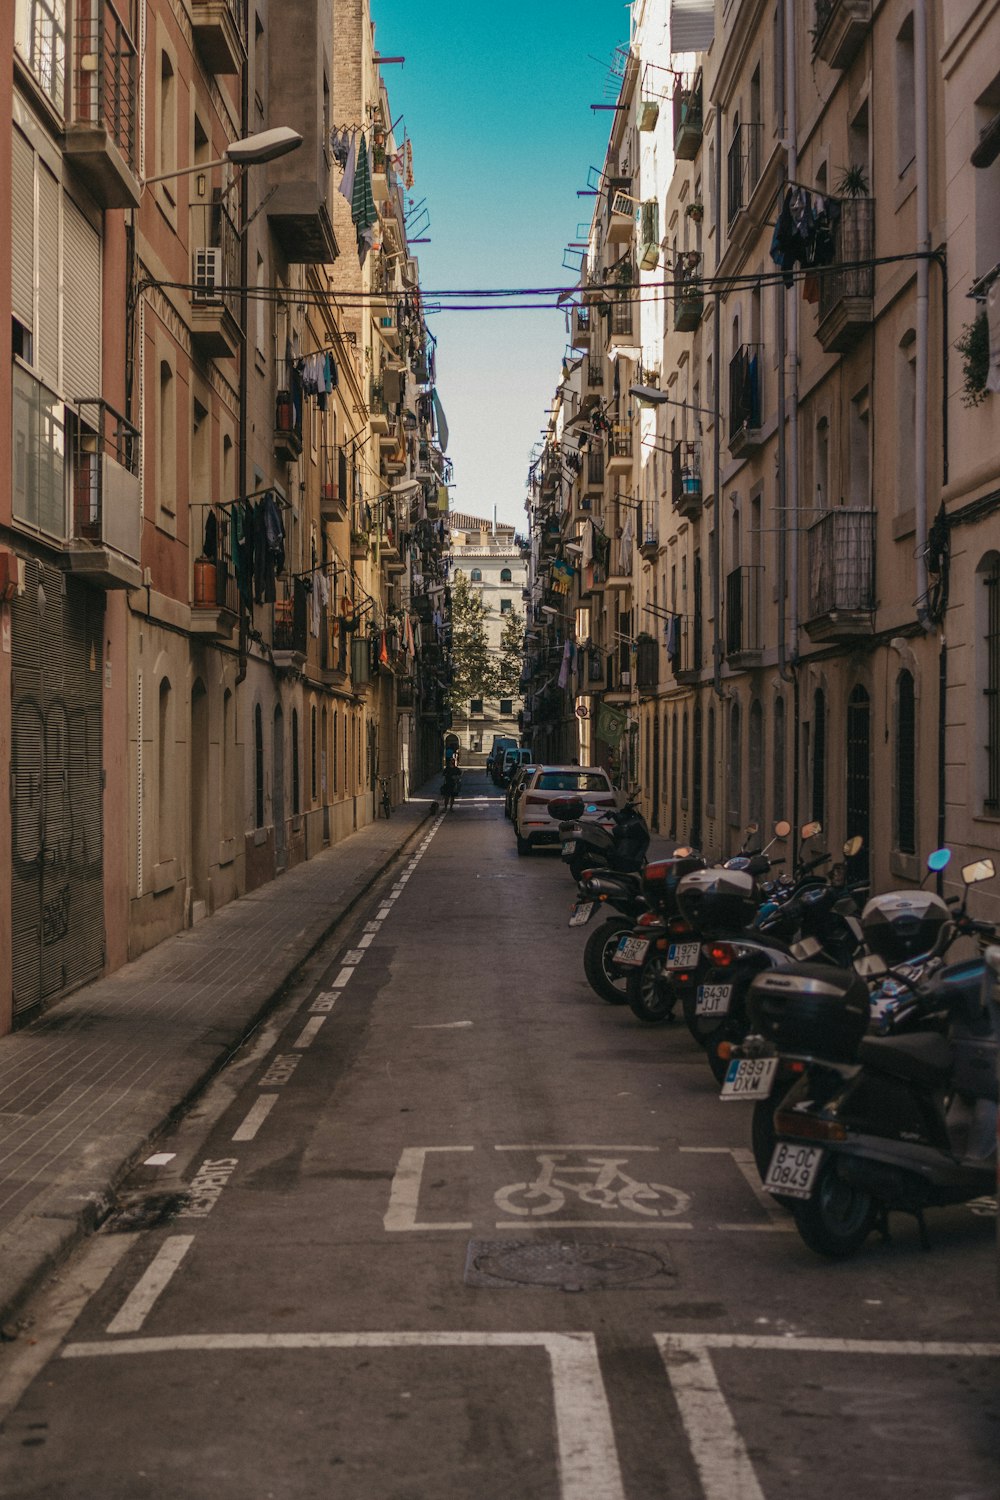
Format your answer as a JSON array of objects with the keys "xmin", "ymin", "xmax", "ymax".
[{"xmin": 0, "ymin": 771, "xmax": 1000, "ymax": 1500}]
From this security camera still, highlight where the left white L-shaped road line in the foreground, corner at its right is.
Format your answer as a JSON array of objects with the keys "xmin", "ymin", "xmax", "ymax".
[{"xmin": 61, "ymin": 1332, "xmax": 626, "ymax": 1500}]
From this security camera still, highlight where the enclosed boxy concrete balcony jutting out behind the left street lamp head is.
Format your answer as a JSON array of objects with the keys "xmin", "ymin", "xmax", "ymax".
[{"xmin": 261, "ymin": 0, "xmax": 337, "ymax": 266}]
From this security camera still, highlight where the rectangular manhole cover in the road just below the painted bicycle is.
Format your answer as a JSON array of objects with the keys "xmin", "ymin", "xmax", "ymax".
[{"xmin": 465, "ymin": 1239, "xmax": 676, "ymax": 1292}]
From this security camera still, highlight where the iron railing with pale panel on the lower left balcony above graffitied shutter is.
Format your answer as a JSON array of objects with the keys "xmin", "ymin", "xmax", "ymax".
[{"xmin": 73, "ymin": 399, "xmax": 142, "ymax": 563}]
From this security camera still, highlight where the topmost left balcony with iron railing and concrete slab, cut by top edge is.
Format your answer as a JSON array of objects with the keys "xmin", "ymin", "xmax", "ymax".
[{"xmin": 64, "ymin": 0, "xmax": 142, "ymax": 209}]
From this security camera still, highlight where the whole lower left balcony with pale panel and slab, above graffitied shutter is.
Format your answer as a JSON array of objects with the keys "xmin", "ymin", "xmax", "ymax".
[{"xmin": 61, "ymin": 399, "xmax": 142, "ymax": 588}]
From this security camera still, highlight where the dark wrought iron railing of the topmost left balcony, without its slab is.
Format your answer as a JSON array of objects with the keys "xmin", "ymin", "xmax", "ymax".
[{"xmin": 72, "ymin": 0, "xmax": 139, "ymax": 173}]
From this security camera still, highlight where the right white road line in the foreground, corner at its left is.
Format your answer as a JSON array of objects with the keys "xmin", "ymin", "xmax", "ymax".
[{"xmin": 654, "ymin": 1334, "xmax": 1000, "ymax": 1500}]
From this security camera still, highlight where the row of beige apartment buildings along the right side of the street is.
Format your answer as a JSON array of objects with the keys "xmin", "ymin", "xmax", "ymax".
[{"xmin": 524, "ymin": 0, "xmax": 1000, "ymax": 906}]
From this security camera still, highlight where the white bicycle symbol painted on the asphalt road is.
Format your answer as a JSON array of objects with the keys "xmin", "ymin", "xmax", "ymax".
[{"xmin": 493, "ymin": 1146, "xmax": 693, "ymax": 1229}]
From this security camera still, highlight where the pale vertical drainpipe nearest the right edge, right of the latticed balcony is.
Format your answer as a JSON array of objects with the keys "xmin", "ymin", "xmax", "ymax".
[{"xmin": 913, "ymin": 0, "xmax": 934, "ymax": 633}]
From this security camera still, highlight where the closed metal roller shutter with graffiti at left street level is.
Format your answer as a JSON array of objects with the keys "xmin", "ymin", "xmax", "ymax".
[{"xmin": 10, "ymin": 561, "xmax": 105, "ymax": 1020}]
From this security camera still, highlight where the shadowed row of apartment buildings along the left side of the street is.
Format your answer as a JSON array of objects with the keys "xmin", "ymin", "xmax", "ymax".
[{"xmin": 0, "ymin": 0, "xmax": 450, "ymax": 1029}]
